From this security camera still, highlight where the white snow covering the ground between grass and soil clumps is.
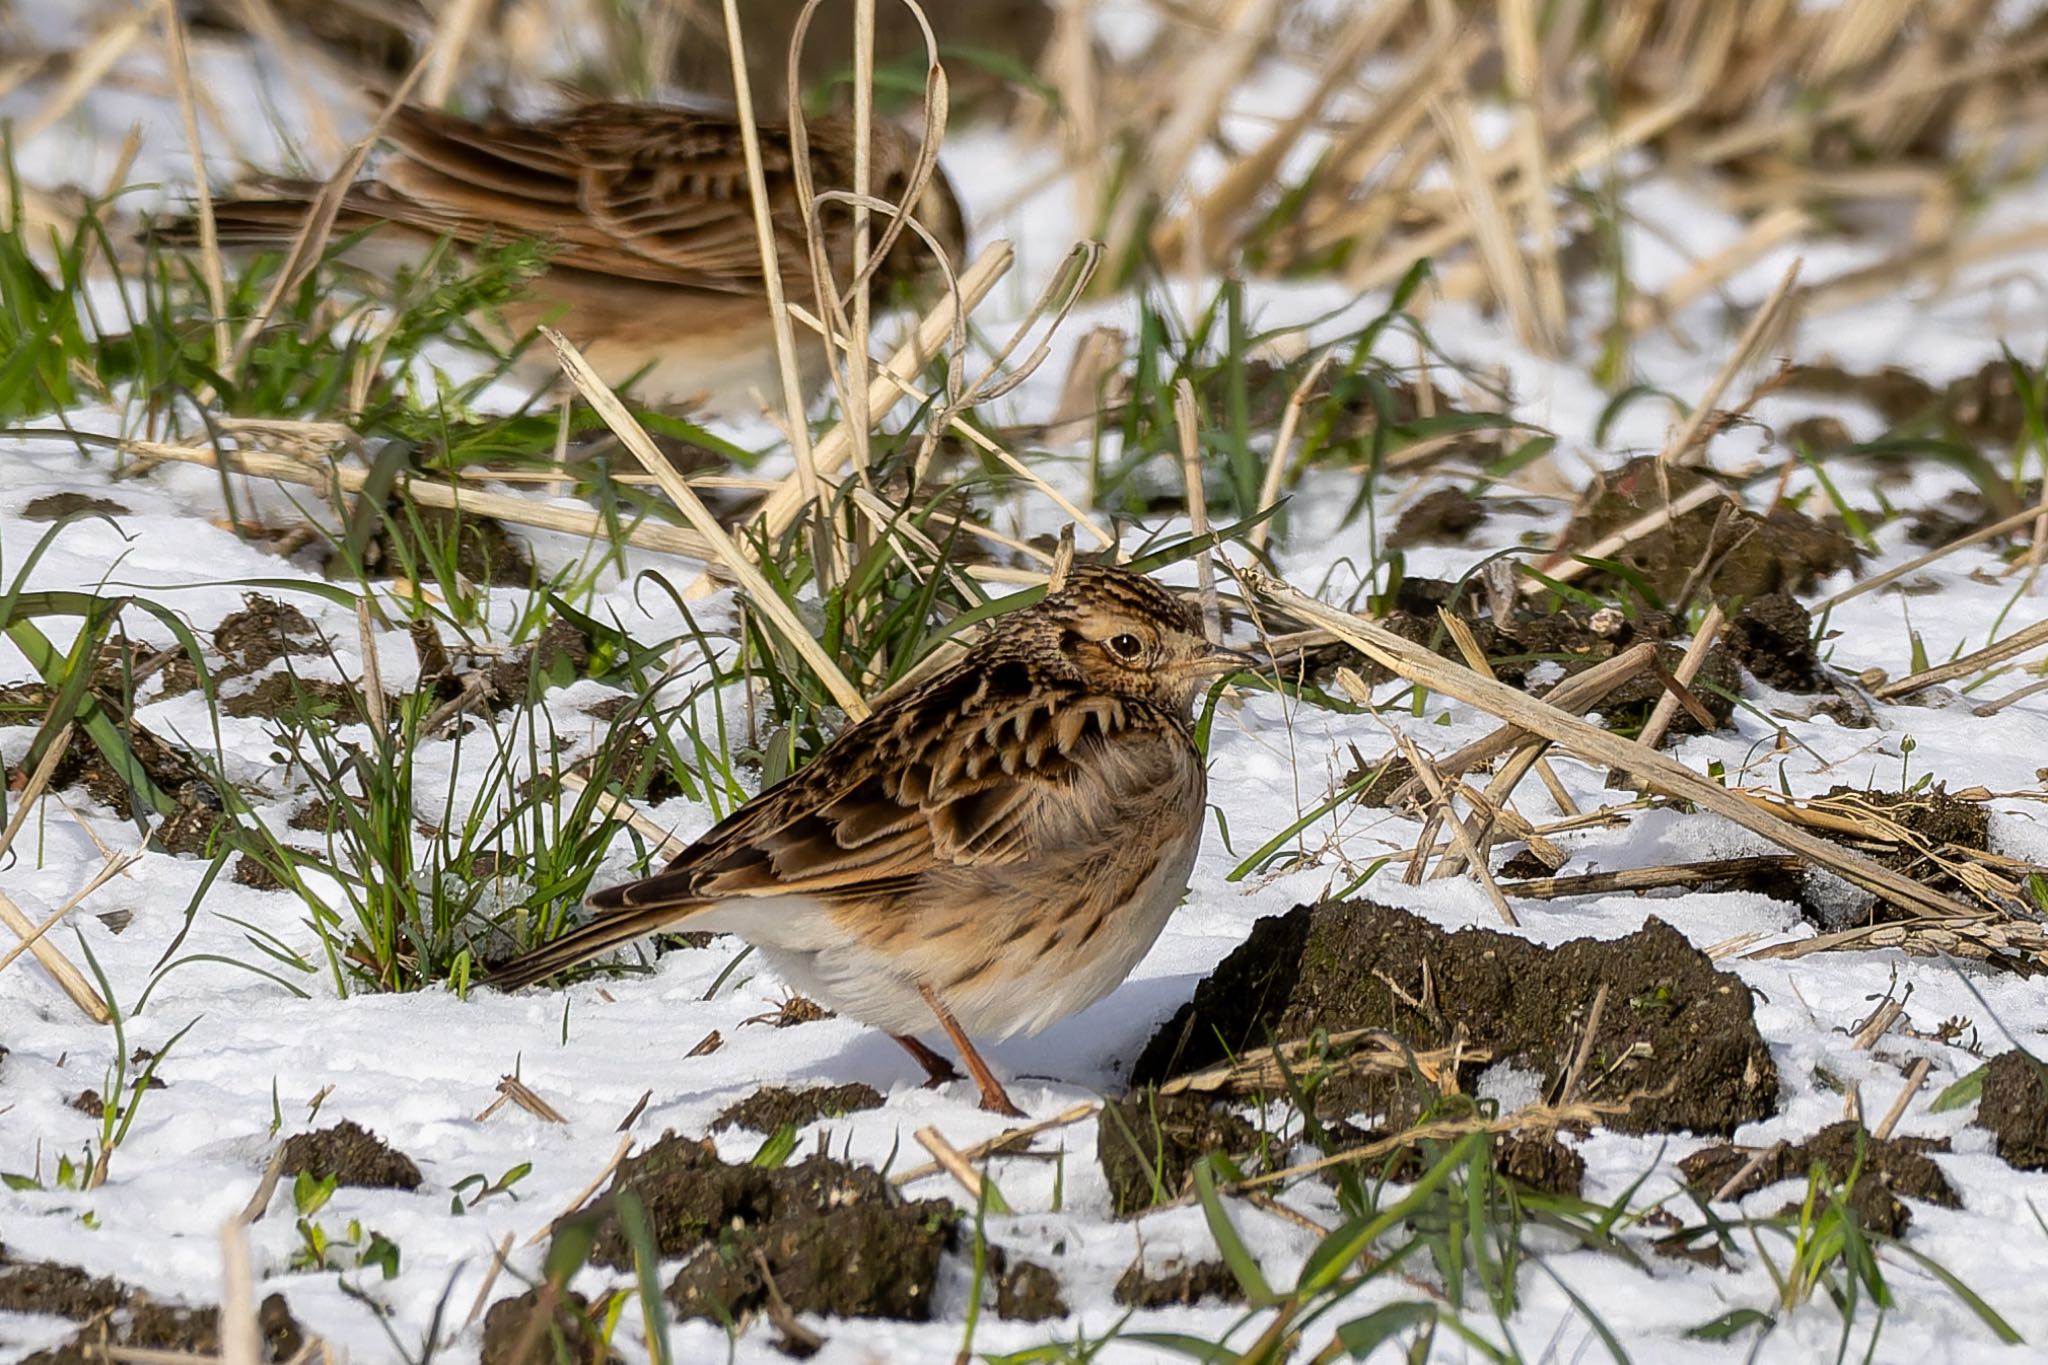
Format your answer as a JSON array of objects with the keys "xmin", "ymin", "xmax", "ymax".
[{"xmin": 0, "ymin": 10, "xmax": 2048, "ymax": 1365}]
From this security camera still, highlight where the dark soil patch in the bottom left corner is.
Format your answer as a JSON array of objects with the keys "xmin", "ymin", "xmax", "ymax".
[{"xmin": 0, "ymin": 1252, "xmax": 305, "ymax": 1365}]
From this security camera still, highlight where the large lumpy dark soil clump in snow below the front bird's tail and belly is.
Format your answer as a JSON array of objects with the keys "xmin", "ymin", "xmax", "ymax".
[{"xmin": 590, "ymin": 1134, "xmax": 956, "ymax": 1322}]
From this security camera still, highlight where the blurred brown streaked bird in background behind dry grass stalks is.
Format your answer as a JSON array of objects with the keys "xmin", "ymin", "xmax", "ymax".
[{"xmin": 166, "ymin": 104, "xmax": 965, "ymax": 411}]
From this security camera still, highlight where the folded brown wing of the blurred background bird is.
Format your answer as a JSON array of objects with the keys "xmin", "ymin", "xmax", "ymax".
[{"xmin": 368, "ymin": 104, "xmax": 809, "ymax": 293}]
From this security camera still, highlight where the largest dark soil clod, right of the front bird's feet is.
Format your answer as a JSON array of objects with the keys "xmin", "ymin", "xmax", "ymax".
[{"xmin": 1133, "ymin": 900, "xmax": 1778, "ymax": 1134}]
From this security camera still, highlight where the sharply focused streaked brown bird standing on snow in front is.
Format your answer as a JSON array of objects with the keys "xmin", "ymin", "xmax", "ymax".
[{"xmin": 487, "ymin": 567, "xmax": 1251, "ymax": 1115}]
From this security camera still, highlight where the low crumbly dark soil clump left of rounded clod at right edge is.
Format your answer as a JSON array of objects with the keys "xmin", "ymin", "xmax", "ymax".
[{"xmin": 1677, "ymin": 1119, "xmax": 1962, "ymax": 1236}]
